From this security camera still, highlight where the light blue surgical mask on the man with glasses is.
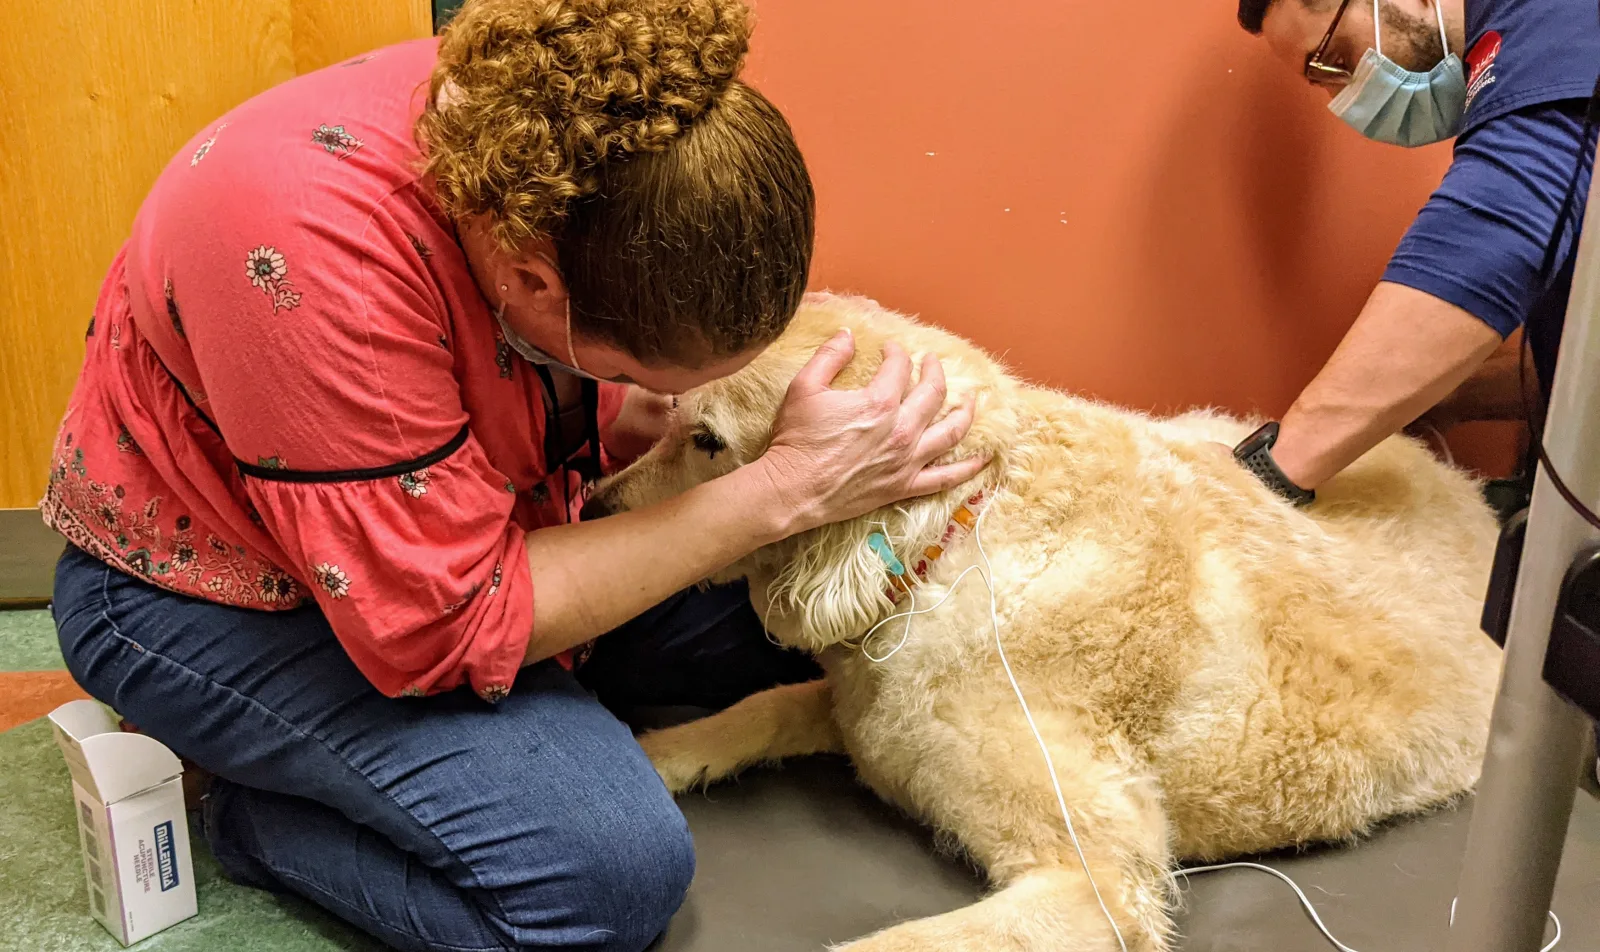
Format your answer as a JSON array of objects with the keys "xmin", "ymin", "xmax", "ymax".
[{"xmin": 1328, "ymin": 0, "xmax": 1467, "ymax": 147}]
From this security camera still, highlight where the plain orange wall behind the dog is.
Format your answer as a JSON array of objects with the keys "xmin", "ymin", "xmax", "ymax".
[{"xmin": 747, "ymin": 0, "xmax": 1506, "ymax": 469}]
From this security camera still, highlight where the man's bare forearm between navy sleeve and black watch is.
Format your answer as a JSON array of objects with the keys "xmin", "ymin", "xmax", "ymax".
[{"xmin": 1272, "ymin": 283, "xmax": 1501, "ymax": 490}]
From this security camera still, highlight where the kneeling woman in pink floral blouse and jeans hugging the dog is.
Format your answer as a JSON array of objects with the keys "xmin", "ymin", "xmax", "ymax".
[{"xmin": 42, "ymin": 0, "xmax": 978, "ymax": 950}]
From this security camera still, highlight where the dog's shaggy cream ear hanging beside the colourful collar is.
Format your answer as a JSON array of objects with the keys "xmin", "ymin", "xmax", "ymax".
[{"xmin": 766, "ymin": 496, "xmax": 946, "ymax": 651}]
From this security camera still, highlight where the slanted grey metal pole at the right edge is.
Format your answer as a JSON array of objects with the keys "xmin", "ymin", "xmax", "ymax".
[{"xmin": 1445, "ymin": 168, "xmax": 1600, "ymax": 952}]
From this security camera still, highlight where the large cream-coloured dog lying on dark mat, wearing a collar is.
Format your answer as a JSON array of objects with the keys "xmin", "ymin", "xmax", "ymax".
[{"xmin": 598, "ymin": 296, "xmax": 1499, "ymax": 952}]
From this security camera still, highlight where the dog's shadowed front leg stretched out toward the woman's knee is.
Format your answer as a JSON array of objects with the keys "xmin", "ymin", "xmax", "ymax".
[{"xmin": 638, "ymin": 680, "xmax": 843, "ymax": 794}]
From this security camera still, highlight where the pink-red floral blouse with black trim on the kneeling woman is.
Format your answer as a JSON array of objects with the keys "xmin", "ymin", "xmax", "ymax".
[{"xmin": 42, "ymin": 40, "xmax": 622, "ymax": 701}]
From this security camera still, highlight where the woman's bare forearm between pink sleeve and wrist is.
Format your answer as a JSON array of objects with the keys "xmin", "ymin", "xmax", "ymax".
[{"xmin": 526, "ymin": 462, "xmax": 792, "ymax": 662}]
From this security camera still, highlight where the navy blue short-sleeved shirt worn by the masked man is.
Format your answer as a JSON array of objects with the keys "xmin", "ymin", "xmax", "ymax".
[{"xmin": 1384, "ymin": 0, "xmax": 1600, "ymax": 386}]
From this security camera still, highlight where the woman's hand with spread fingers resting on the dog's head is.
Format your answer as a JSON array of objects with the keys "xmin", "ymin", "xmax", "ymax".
[{"xmin": 757, "ymin": 331, "xmax": 989, "ymax": 531}]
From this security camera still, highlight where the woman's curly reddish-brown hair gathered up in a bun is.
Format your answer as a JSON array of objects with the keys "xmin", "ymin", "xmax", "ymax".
[{"xmin": 416, "ymin": 0, "xmax": 814, "ymax": 365}]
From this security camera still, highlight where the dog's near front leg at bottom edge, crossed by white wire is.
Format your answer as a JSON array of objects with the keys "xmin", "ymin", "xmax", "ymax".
[{"xmin": 845, "ymin": 710, "xmax": 1171, "ymax": 952}]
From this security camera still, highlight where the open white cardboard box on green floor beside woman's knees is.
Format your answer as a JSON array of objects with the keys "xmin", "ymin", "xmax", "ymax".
[{"xmin": 50, "ymin": 701, "xmax": 197, "ymax": 946}]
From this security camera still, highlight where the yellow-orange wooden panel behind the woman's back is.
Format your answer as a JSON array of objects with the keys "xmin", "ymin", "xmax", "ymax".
[{"xmin": 0, "ymin": 0, "xmax": 432, "ymax": 509}]
